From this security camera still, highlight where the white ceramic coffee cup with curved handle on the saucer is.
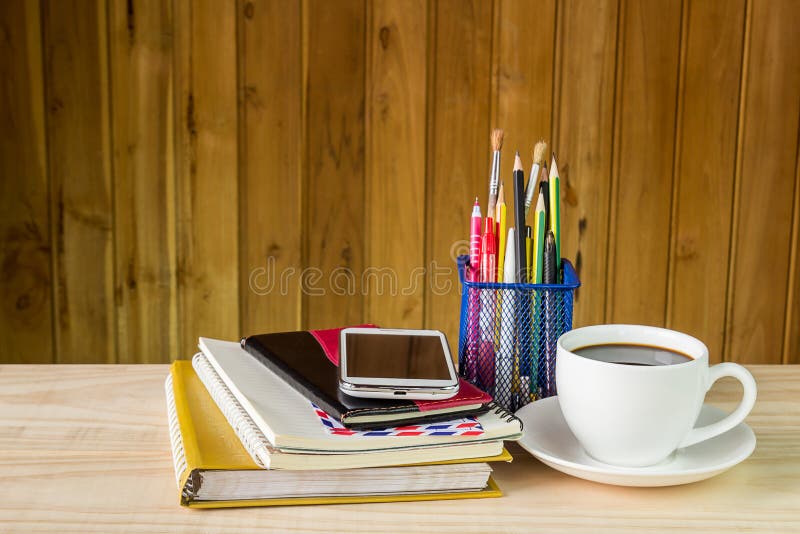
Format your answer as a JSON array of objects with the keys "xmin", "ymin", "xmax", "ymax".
[{"xmin": 556, "ymin": 325, "xmax": 756, "ymax": 467}]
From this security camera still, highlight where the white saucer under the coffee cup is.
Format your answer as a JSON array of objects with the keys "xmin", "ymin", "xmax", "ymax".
[{"xmin": 516, "ymin": 397, "xmax": 756, "ymax": 486}]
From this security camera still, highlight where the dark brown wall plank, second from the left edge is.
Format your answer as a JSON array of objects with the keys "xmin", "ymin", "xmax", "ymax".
[{"xmin": 42, "ymin": 0, "xmax": 116, "ymax": 363}]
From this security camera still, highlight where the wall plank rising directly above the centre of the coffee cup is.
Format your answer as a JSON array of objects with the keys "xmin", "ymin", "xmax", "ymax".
[{"xmin": 606, "ymin": 0, "xmax": 681, "ymax": 326}]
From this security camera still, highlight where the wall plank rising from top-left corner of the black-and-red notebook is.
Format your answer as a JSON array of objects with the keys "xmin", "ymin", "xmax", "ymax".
[{"xmin": 237, "ymin": 0, "xmax": 303, "ymax": 336}]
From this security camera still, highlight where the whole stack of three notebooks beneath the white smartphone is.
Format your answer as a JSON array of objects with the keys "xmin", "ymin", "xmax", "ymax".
[{"xmin": 166, "ymin": 330, "xmax": 522, "ymax": 508}]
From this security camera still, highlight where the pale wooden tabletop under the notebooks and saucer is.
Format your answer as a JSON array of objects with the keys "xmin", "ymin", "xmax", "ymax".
[{"xmin": 0, "ymin": 365, "xmax": 800, "ymax": 533}]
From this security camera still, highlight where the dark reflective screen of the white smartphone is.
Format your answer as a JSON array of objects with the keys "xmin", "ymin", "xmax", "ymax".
[{"xmin": 345, "ymin": 333, "xmax": 450, "ymax": 380}]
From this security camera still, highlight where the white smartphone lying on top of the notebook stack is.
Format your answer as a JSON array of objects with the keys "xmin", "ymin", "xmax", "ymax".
[{"xmin": 339, "ymin": 328, "xmax": 458, "ymax": 400}]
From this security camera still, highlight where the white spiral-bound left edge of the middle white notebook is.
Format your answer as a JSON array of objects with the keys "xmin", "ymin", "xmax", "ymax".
[{"xmin": 192, "ymin": 352, "xmax": 273, "ymax": 469}]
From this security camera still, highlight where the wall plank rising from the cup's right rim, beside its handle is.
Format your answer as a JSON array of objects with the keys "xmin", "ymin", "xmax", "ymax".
[{"xmin": 667, "ymin": 0, "xmax": 745, "ymax": 361}]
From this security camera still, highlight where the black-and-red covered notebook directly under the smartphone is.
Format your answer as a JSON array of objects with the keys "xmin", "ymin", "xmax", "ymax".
[{"xmin": 242, "ymin": 325, "xmax": 493, "ymax": 429}]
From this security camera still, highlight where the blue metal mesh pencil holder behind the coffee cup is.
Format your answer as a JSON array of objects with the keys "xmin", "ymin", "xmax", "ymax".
[{"xmin": 458, "ymin": 256, "xmax": 581, "ymax": 411}]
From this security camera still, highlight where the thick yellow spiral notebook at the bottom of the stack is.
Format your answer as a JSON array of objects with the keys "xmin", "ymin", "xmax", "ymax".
[{"xmin": 165, "ymin": 361, "xmax": 511, "ymax": 508}]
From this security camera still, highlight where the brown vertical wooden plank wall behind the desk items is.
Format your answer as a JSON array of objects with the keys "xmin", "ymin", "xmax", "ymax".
[{"xmin": 0, "ymin": 0, "xmax": 800, "ymax": 363}]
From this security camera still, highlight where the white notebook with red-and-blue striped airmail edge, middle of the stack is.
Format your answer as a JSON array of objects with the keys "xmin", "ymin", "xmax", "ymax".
[{"xmin": 195, "ymin": 338, "xmax": 522, "ymax": 454}]
